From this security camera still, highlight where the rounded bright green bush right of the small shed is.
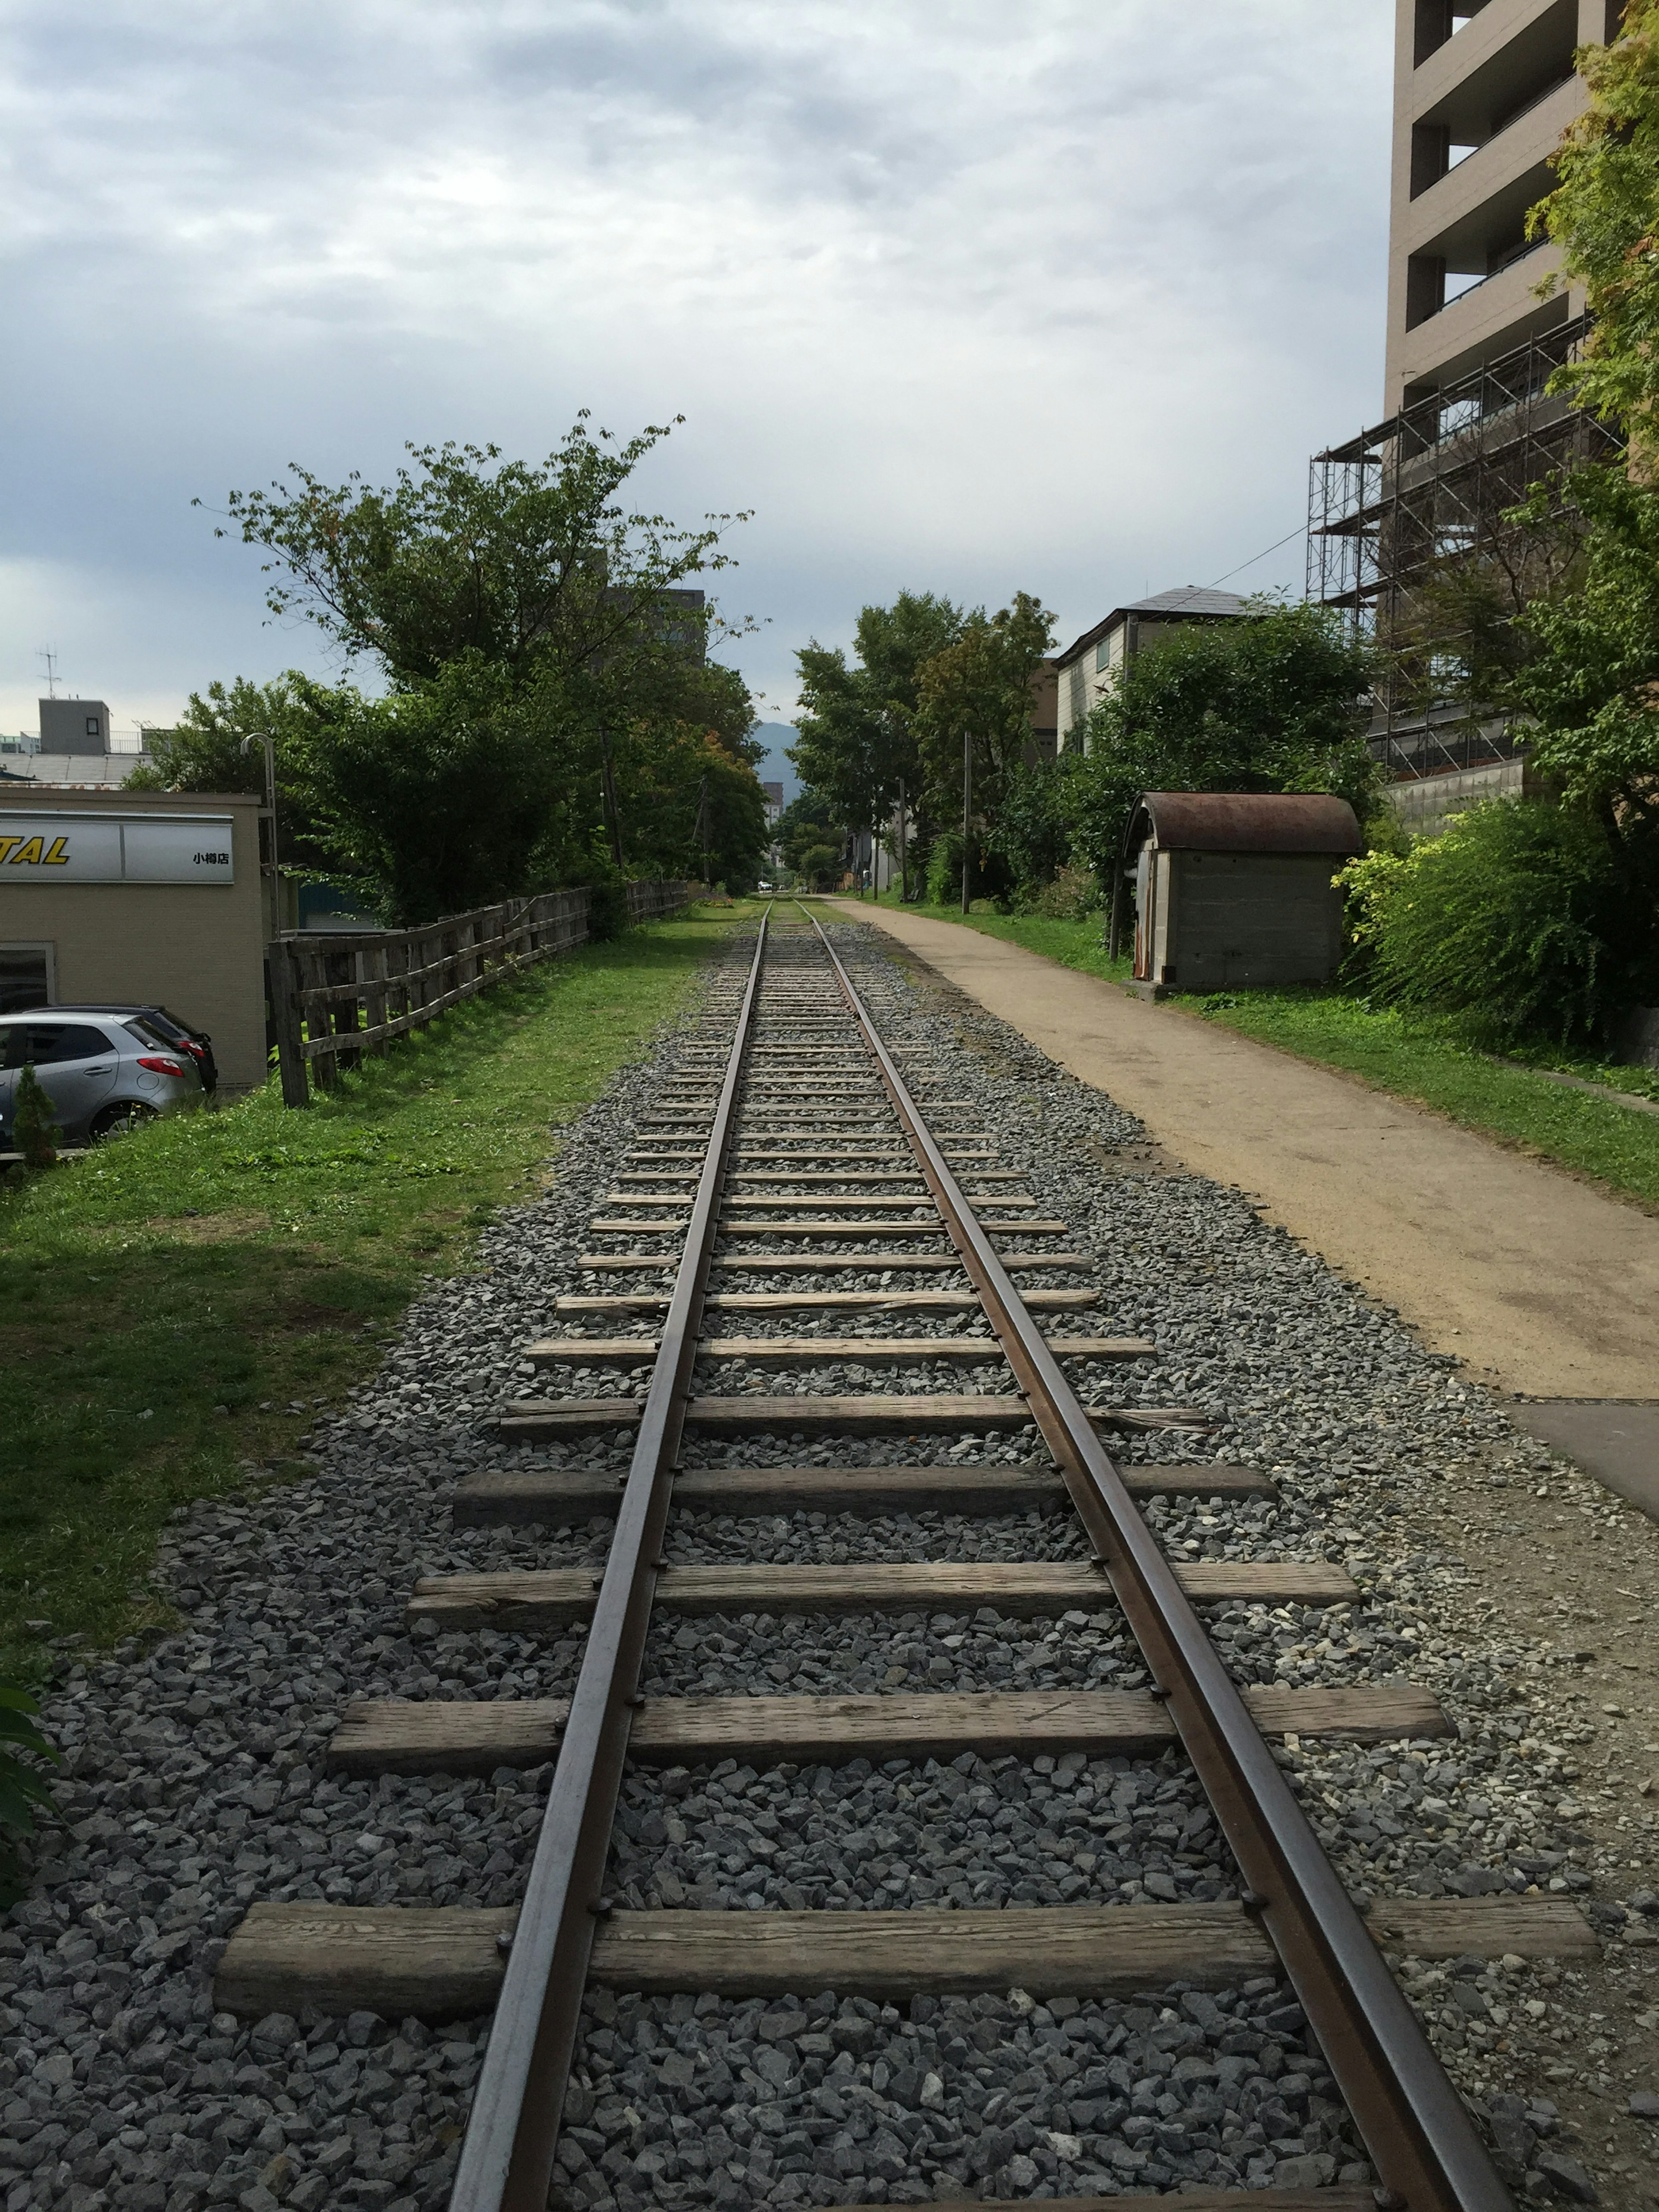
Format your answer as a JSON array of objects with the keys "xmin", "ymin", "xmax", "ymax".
[{"xmin": 1338, "ymin": 798, "xmax": 1655, "ymax": 1044}]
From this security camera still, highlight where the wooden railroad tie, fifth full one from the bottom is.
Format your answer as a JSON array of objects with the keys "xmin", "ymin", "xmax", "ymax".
[{"xmin": 491, "ymin": 1391, "xmax": 1219, "ymax": 1440}]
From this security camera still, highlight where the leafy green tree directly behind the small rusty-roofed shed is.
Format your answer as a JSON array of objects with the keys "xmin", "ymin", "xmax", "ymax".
[{"xmin": 1066, "ymin": 600, "xmax": 1380, "ymax": 883}]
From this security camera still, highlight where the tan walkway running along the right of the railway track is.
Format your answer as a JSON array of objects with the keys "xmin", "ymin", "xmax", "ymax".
[{"xmin": 834, "ymin": 900, "xmax": 1659, "ymax": 1400}]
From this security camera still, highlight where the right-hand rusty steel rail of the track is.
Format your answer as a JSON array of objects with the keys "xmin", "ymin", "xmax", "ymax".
[{"xmin": 801, "ymin": 907, "xmax": 1513, "ymax": 2212}]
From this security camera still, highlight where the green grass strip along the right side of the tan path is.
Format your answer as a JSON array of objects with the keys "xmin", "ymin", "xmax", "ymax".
[{"xmin": 845, "ymin": 893, "xmax": 1659, "ymax": 1210}]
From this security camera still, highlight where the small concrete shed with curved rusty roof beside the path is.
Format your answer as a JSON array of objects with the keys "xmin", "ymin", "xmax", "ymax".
[{"xmin": 1112, "ymin": 792, "xmax": 1363, "ymax": 993}]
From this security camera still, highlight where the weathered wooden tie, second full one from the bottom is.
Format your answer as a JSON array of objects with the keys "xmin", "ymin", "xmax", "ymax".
[{"xmin": 327, "ymin": 1683, "xmax": 1456, "ymax": 1774}]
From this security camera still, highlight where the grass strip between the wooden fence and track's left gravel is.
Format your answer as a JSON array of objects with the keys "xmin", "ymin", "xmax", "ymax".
[{"xmin": 0, "ymin": 907, "xmax": 745, "ymax": 1681}]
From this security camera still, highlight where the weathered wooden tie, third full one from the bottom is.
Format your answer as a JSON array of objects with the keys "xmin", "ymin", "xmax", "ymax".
[{"xmin": 405, "ymin": 1560, "xmax": 1360, "ymax": 1635}]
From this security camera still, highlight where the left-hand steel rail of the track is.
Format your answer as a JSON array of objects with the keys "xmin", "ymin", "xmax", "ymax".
[{"xmin": 449, "ymin": 907, "xmax": 772, "ymax": 2212}]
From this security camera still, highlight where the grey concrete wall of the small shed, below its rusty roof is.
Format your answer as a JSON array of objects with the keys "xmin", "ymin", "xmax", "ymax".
[{"xmin": 1153, "ymin": 852, "xmax": 1343, "ymax": 991}]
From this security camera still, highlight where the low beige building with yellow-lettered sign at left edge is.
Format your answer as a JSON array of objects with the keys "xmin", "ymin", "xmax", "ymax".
[{"xmin": 0, "ymin": 783, "xmax": 265, "ymax": 1090}]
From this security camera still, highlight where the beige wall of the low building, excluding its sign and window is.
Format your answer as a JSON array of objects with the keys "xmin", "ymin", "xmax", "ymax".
[{"xmin": 0, "ymin": 785, "xmax": 265, "ymax": 1090}]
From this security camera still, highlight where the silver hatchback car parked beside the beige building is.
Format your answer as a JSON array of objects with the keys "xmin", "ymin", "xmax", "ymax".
[{"xmin": 0, "ymin": 1007, "xmax": 201, "ymax": 1150}]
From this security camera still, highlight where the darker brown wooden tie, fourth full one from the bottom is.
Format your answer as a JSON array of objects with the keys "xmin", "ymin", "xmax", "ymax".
[{"xmin": 451, "ymin": 1462, "xmax": 1276, "ymax": 1529}]
